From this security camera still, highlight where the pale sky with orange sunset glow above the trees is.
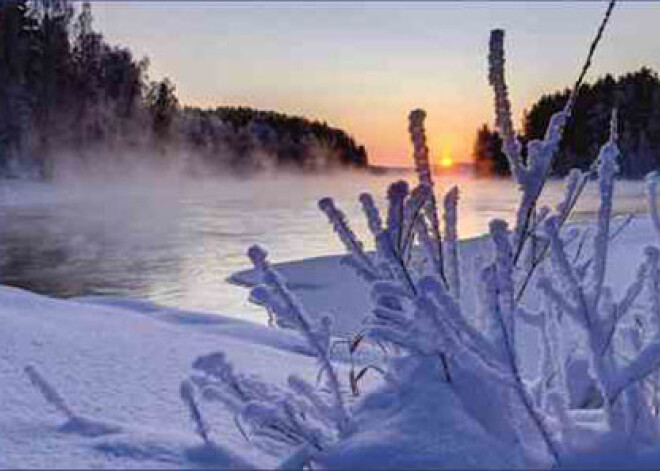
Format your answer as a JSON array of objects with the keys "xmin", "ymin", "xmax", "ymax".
[{"xmin": 92, "ymin": 1, "xmax": 660, "ymax": 166}]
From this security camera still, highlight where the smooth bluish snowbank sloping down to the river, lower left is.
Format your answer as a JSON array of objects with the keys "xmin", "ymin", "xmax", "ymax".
[{"xmin": 0, "ymin": 287, "xmax": 324, "ymax": 468}]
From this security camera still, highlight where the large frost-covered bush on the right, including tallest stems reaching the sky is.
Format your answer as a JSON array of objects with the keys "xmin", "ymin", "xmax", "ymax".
[{"xmin": 312, "ymin": 3, "xmax": 658, "ymax": 462}]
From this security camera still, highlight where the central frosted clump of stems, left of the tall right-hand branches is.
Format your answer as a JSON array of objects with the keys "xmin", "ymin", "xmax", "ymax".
[{"xmin": 318, "ymin": 115, "xmax": 558, "ymax": 459}]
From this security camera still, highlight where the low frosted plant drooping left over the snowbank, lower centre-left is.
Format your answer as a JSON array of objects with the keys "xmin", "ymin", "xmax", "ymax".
[{"xmin": 181, "ymin": 247, "xmax": 354, "ymax": 466}]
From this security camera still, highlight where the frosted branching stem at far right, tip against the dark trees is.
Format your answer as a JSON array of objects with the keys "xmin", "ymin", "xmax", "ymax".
[{"xmin": 539, "ymin": 112, "xmax": 660, "ymax": 430}]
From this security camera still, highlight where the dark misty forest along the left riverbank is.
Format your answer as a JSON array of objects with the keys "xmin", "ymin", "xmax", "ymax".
[{"xmin": 0, "ymin": 0, "xmax": 367, "ymax": 178}]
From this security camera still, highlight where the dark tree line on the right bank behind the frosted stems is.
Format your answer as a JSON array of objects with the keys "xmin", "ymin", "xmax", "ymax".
[{"xmin": 474, "ymin": 67, "xmax": 660, "ymax": 178}]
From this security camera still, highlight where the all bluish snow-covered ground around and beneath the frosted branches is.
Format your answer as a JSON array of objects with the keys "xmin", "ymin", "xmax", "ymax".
[{"xmin": 0, "ymin": 217, "xmax": 657, "ymax": 468}]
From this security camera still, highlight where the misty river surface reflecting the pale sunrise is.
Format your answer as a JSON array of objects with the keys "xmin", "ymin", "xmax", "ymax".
[{"xmin": 0, "ymin": 172, "xmax": 645, "ymax": 322}]
